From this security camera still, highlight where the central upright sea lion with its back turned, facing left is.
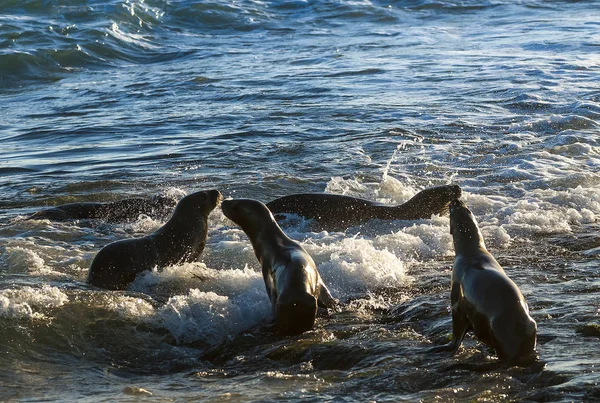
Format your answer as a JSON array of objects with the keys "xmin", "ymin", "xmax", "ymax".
[{"xmin": 221, "ymin": 199, "xmax": 336, "ymax": 334}]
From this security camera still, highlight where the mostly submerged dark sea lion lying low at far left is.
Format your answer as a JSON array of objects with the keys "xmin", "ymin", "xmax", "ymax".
[{"xmin": 27, "ymin": 195, "xmax": 177, "ymax": 222}]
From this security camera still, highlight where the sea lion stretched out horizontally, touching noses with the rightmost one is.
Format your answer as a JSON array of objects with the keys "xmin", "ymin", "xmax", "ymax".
[{"xmin": 267, "ymin": 185, "xmax": 461, "ymax": 231}]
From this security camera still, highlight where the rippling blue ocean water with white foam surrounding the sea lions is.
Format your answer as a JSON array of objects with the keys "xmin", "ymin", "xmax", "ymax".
[{"xmin": 0, "ymin": 0, "xmax": 600, "ymax": 402}]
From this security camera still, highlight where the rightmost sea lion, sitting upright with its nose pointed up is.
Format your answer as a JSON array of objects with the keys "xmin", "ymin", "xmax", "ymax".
[{"xmin": 432, "ymin": 200, "xmax": 537, "ymax": 364}]
